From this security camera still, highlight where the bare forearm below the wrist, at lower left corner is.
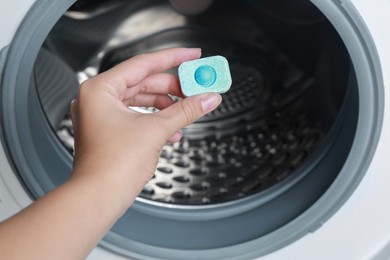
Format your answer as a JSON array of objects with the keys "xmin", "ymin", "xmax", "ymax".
[{"xmin": 0, "ymin": 173, "xmax": 136, "ymax": 259}]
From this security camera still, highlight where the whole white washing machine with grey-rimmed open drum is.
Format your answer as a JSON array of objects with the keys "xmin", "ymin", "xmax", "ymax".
[{"xmin": 0, "ymin": 0, "xmax": 390, "ymax": 260}]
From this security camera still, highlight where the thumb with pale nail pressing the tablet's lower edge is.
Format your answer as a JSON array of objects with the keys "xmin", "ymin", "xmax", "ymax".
[{"xmin": 159, "ymin": 93, "xmax": 222, "ymax": 133}]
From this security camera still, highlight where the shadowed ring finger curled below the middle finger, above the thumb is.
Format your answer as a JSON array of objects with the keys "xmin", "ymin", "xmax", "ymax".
[{"xmin": 123, "ymin": 94, "xmax": 175, "ymax": 109}]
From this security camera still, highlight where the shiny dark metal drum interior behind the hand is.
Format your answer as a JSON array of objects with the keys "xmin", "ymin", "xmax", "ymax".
[{"xmin": 34, "ymin": 1, "xmax": 347, "ymax": 205}]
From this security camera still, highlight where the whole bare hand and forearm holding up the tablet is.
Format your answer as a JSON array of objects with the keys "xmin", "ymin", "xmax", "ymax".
[{"xmin": 0, "ymin": 49, "xmax": 221, "ymax": 260}]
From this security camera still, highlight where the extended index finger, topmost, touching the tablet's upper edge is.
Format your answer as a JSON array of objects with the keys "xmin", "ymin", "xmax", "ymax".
[{"xmin": 95, "ymin": 48, "xmax": 201, "ymax": 100}]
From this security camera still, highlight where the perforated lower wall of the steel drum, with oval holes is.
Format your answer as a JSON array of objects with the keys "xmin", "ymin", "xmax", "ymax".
[{"xmin": 145, "ymin": 103, "xmax": 321, "ymax": 205}]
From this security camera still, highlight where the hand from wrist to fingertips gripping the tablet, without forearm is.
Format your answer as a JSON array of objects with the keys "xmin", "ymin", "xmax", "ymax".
[{"xmin": 71, "ymin": 48, "xmax": 222, "ymax": 211}]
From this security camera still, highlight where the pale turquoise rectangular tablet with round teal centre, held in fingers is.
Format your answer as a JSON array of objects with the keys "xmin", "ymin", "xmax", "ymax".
[{"xmin": 179, "ymin": 56, "xmax": 232, "ymax": 97}]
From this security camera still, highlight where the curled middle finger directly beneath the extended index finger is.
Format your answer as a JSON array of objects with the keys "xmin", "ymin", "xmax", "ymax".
[{"xmin": 124, "ymin": 73, "xmax": 183, "ymax": 99}]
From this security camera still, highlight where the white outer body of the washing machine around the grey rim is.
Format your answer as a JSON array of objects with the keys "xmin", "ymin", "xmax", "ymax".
[{"xmin": 0, "ymin": 0, "xmax": 390, "ymax": 259}]
